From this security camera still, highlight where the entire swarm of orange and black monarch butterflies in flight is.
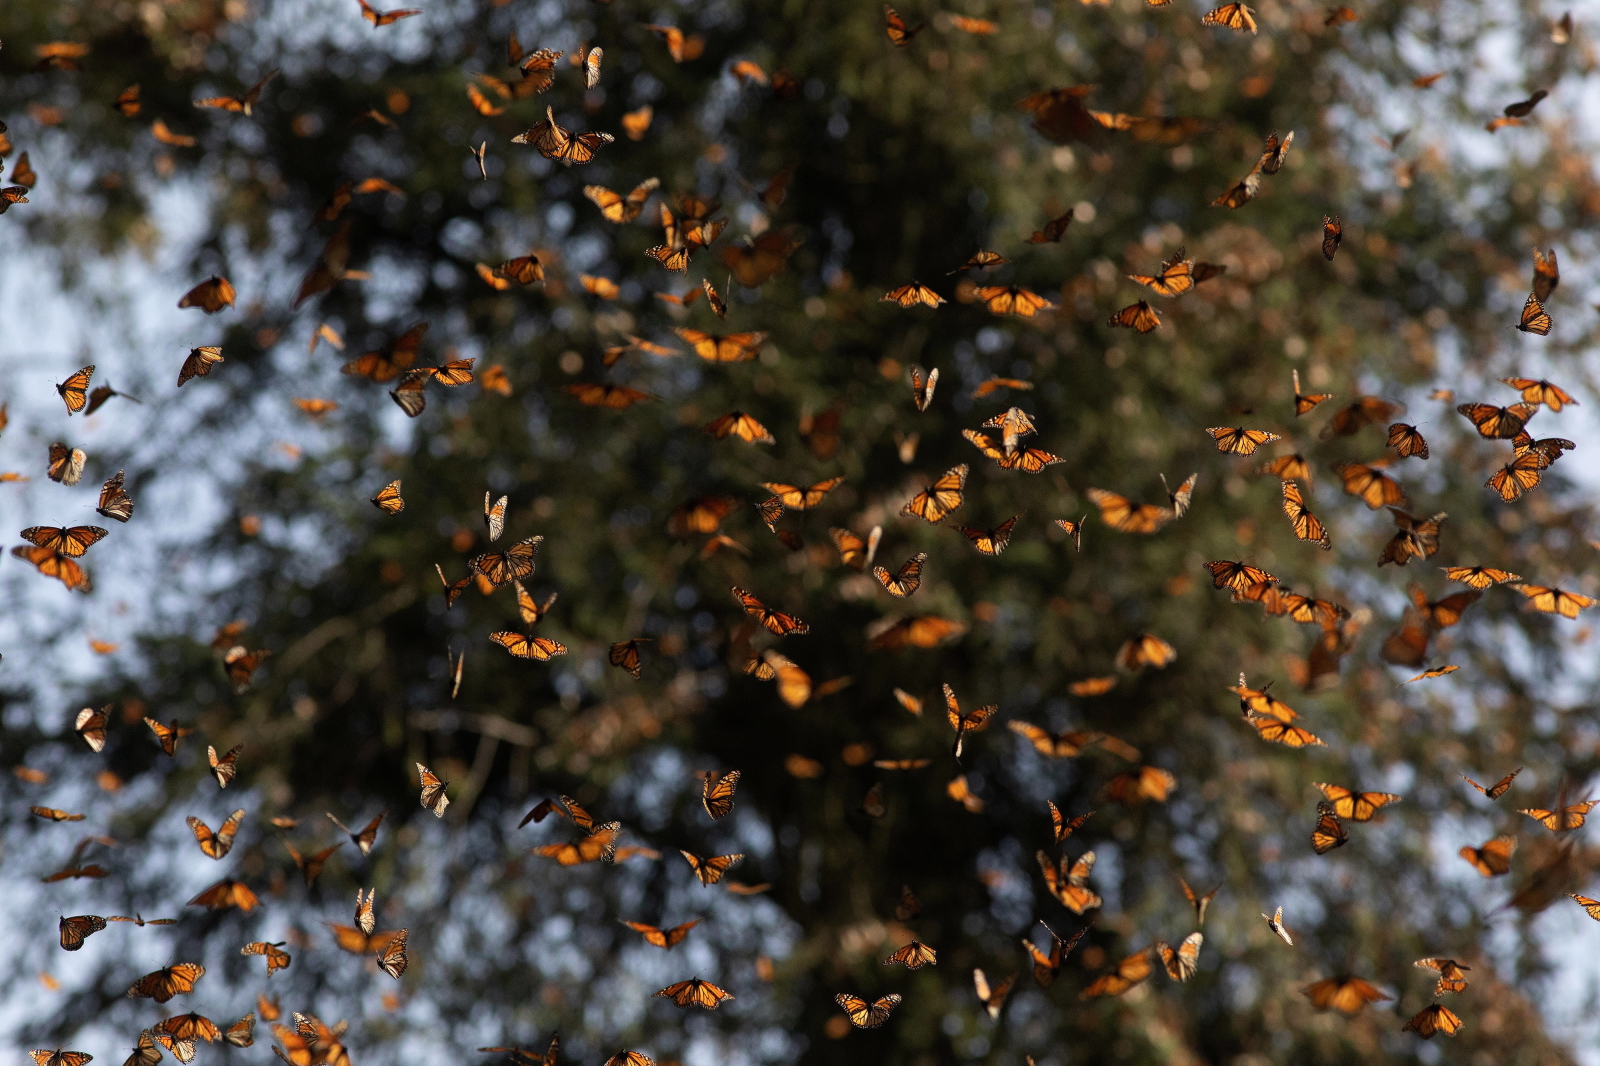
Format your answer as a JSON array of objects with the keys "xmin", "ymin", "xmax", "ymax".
[{"xmin": 0, "ymin": 0, "xmax": 1600, "ymax": 1066}]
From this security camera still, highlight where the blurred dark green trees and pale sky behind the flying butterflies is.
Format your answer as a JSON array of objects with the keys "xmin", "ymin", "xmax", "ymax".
[{"xmin": 0, "ymin": 0, "xmax": 1600, "ymax": 1066}]
